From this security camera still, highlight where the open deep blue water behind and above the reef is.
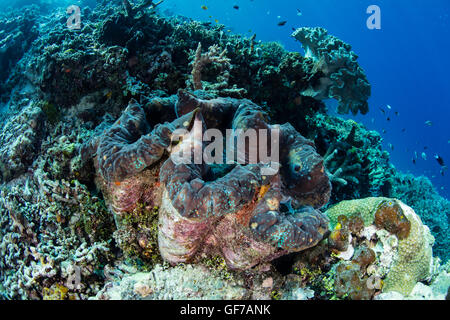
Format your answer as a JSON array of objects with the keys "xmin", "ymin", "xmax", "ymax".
[{"xmin": 0, "ymin": 0, "xmax": 450, "ymax": 198}]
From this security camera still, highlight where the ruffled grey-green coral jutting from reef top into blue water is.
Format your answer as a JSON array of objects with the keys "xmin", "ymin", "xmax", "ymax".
[{"xmin": 292, "ymin": 28, "xmax": 370, "ymax": 114}]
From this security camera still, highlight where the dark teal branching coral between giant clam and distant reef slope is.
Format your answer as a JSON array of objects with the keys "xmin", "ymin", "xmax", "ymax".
[{"xmin": 306, "ymin": 113, "xmax": 396, "ymax": 203}]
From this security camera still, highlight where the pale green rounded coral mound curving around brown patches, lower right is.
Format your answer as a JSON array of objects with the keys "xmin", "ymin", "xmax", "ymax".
[{"xmin": 326, "ymin": 197, "xmax": 434, "ymax": 295}]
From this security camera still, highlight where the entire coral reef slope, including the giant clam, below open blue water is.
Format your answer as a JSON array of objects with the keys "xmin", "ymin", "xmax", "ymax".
[{"xmin": 0, "ymin": 0, "xmax": 449, "ymax": 300}]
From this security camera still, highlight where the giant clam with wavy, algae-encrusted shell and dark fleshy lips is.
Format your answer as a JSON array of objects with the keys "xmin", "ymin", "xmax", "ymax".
[{"xmin": 85, "ymin": 90, "xmax": 331, "ymax": 269}]
